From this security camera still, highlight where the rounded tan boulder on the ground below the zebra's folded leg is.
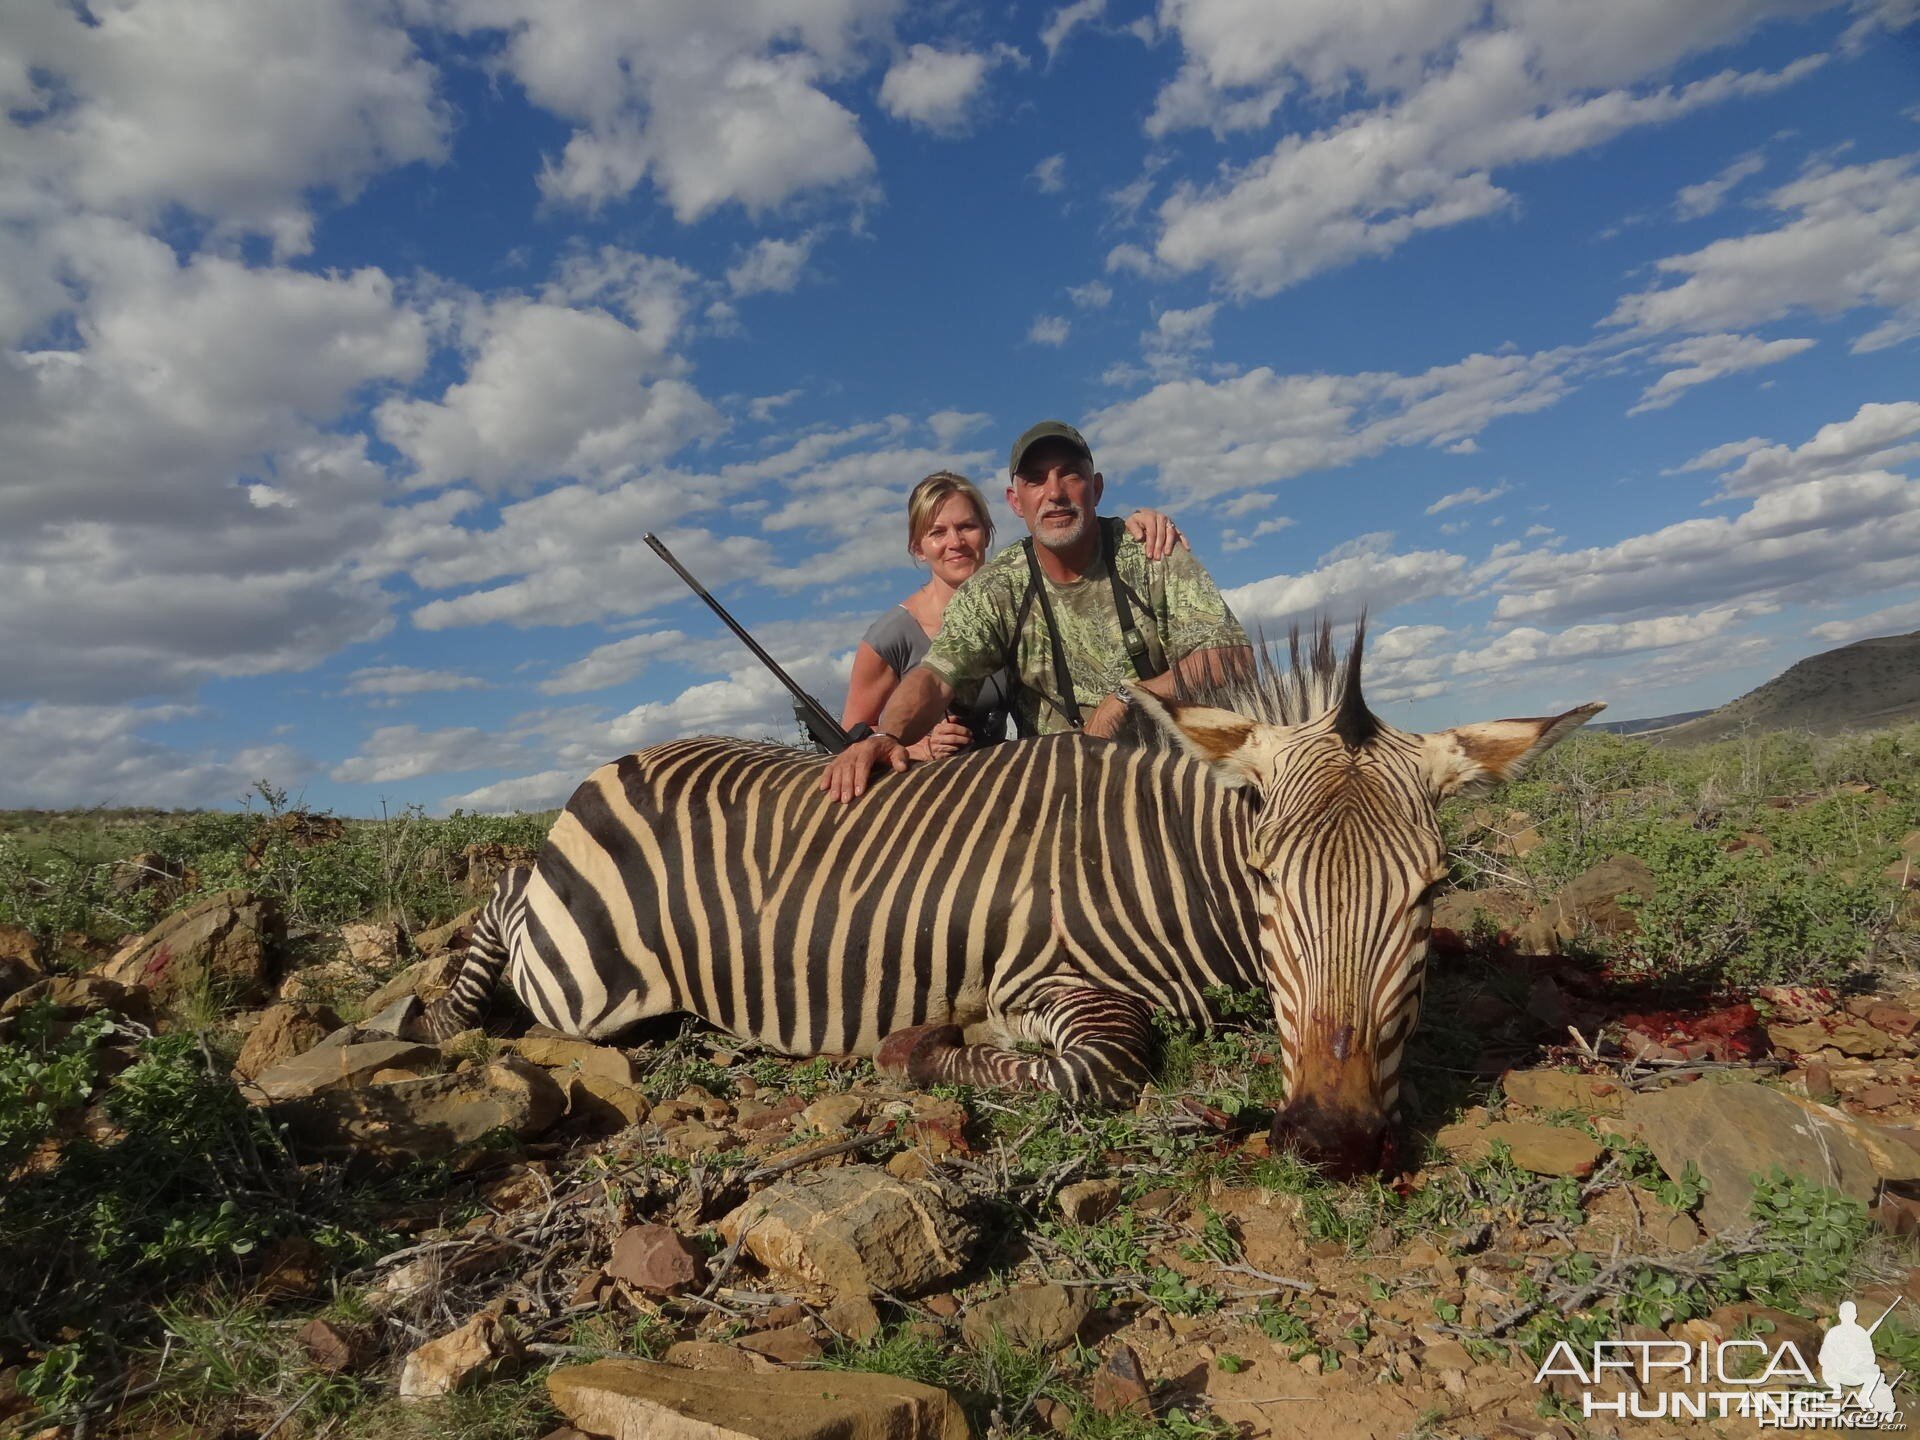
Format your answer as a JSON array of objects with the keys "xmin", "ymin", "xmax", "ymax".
[{"xmin": 718, "ymin": 1165, "xmax": 977, "ymax": 1296}]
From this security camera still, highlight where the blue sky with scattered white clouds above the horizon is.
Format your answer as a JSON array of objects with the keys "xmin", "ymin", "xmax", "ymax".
[{"xmin": 0, "ymin": 0, "xmax": 1920, "ymax": 814}]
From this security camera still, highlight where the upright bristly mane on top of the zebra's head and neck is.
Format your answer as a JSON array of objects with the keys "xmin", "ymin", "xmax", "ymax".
[{"xmin": 1117, "ymin": 616, "xmax": 1380, "ymax": 749}]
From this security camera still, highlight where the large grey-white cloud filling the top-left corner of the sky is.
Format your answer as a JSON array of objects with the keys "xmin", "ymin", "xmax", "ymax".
[{"xmin": 0, "ymin": 0, "xmax": 451, "ymax": 255}]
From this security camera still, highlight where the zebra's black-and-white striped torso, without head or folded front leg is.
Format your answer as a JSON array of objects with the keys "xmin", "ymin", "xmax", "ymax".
[{"xmin": 443, "ymin": 735, "xmax": 1261, "ymax": 1082}]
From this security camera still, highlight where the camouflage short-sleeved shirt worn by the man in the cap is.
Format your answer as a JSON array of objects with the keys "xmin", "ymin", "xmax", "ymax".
[{"xmin": 922, "ymin": 532, "xmax": 1246, "ymax": 735}]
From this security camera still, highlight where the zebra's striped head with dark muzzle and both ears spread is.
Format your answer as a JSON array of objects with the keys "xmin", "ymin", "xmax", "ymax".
[{"xmin": 1135, "ymin": 628, "xmax": 1605, "ymax": 1175}]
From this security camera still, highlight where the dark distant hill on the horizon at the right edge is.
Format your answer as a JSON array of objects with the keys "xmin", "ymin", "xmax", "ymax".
[{"xmin": 1640, "ymin": 630, "xmax": 1920, "ymax": 745}]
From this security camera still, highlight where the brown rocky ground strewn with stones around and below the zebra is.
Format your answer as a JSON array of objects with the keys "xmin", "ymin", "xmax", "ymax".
[{"xmin": 0, "ymin": 833, "xmax": 1920, "ymax": 1440}]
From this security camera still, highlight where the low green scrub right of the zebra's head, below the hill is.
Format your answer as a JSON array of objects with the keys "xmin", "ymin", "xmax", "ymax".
[{"xmin": 1442, "ymin": 726, "xmax": 1920, "ymax": 987}]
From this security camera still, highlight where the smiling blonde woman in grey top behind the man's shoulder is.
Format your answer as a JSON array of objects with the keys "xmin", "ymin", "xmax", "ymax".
[{"xmin": 841, "ymin": 470, "xmax": 1185, "ymax": 760}]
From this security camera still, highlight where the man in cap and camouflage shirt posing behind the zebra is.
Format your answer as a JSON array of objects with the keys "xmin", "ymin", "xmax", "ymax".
[{"xmin": 820, "ymin": 420, "xmax": 1252, "ymax": 801}]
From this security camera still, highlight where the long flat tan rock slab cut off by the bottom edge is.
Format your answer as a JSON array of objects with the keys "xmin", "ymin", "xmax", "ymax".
[{"xmin": 547, "ymin": 1359, "xmax": 970, "ymax": 1440}]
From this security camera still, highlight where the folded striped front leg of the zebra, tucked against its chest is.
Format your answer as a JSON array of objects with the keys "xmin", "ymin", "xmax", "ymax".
[{"xmin": 874, "ymin": 985, "xmax": 1154, "ymax": 1106}]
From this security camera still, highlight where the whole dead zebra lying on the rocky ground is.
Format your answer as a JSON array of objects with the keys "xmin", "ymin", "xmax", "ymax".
[{"xmin": 417, "ymin": 626, "xmax": 1603, "ymax": 1173}]
